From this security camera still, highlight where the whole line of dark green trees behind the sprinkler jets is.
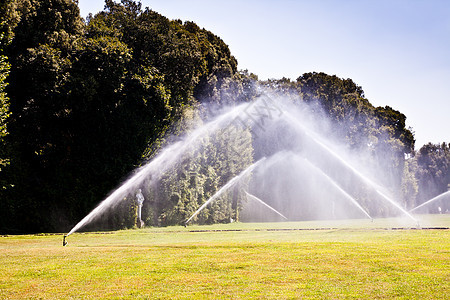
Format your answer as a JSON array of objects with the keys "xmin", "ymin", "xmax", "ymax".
[{"xmin": 0, "ymin": 0, "xmax": 450, "ymax": 233}]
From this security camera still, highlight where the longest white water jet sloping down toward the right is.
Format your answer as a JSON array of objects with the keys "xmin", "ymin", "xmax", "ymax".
[{"xmin": 285, "ymin": 112, "xmax": 419, "ymax": 226}]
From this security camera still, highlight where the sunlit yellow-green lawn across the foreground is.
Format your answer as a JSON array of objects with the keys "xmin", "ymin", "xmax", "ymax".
[{"xmin": 0, "ymin": 215, "xmax": 450, "ymax": 299}]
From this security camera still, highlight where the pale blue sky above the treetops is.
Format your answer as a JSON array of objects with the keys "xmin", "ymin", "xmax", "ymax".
[{"xmin": 79, "ymin": 0, "xmax": 450, "ymax": 149}]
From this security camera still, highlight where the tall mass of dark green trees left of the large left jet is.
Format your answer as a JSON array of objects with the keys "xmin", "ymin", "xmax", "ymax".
[{"xmin": 0, "ymin": 0, "xmax": 243, "ymax": 231}]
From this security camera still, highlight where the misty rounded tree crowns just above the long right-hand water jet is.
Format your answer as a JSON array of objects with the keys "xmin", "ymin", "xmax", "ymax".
[{"xmin": 297, "ymin": 73, "xmax": 415, "ymax": 196}]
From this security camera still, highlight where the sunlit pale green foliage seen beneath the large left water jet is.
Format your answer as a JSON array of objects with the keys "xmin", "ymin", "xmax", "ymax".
[{"xmin": 144, "ymin": 112, "xmax": 253, "ymax": 226}]
